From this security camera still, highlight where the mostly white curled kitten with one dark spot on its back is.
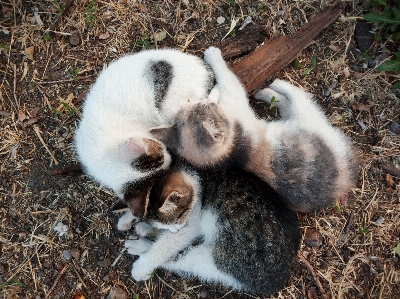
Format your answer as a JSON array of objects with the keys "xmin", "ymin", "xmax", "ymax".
[{"xmin": 75, "ymin": 50, "xmax": 214, "ymax": 223}]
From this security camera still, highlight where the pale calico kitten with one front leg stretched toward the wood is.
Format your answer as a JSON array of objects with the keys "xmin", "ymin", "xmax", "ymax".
[{"xmin": 151, "ymin": 47, "xmax": 358, "ymax": 212}]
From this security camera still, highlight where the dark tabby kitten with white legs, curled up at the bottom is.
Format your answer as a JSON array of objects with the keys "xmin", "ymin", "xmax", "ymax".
[{"xmin": 125, "ymin": 158, "xmax": 301, "ymax": 295}]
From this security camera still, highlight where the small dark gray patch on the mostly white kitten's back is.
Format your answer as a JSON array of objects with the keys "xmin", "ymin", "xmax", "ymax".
[{"xmin": 149, "ymin": 60, "xmax": 173, "ymax": 109}]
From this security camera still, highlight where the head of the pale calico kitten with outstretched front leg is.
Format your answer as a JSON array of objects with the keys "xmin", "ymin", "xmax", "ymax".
[{"xmin": 150, "ymin": 101, "xmax": 235, "ymax": 167}]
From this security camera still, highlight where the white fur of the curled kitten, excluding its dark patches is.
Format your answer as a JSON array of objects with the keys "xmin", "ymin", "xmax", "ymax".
[{"xmin": 75, "ymin": 50, "xmax": 214, "ymax": 198}]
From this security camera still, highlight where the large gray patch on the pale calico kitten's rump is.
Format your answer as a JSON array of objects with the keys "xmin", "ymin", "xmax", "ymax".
[{"xmin": 272, "ymin": 134, "xmax": 339, "ymax": 212}]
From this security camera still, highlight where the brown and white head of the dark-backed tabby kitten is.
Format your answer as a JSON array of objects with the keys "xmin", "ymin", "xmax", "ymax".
[{"xmin": 144, "ymin": 170, "xmax": 199, "ymax": 232}]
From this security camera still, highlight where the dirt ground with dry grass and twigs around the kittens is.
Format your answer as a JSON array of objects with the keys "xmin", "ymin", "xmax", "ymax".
[{"xmin": 0, "ymin": 0, "xmax": 400, "ymax": 299}]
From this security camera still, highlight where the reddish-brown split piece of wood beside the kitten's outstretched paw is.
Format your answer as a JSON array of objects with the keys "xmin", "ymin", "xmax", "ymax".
[{"xmin": 230, "ymin": 2, "xmax": 342, "ymax": 94}]
